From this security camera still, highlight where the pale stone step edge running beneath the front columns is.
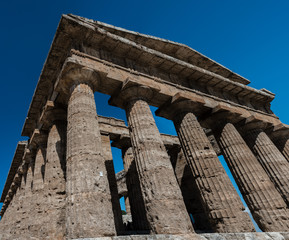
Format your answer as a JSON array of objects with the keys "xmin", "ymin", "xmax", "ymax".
[{"xmin": 72, "ymin": 232, "xmax": 289, "ymax": 240}]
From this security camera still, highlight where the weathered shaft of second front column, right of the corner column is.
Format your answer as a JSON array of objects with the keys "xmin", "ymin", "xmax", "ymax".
[{"xmin": 126, "ymin": 96, "xmax": 193, "ymax": 234}]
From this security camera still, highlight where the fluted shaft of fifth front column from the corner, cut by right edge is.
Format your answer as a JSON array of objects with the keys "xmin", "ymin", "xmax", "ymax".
[{"xmin": 245, "ymin": 128, "xmax": 289, "ymax": 206}]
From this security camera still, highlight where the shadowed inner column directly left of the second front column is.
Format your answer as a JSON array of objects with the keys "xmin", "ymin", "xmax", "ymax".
[{"xmin": 122, "ymin": 147, "xmax": 149, "ymax": 231}]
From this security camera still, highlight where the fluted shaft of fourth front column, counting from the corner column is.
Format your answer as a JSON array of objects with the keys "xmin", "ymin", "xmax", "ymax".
[{"xmin": 214, "ymin": 123, "xmax": 289, "ymax": 232}]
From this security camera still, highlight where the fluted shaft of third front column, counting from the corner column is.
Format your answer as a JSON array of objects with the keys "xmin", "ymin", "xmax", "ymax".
[{"xmin": 174, "ymin": 112, "xmax": 254, "ymax": 232}]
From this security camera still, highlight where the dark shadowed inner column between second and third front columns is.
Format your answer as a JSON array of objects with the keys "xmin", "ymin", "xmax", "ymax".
[{"xmin": 168, "ymin": 147, "xmax": 212, "ymax": 232}]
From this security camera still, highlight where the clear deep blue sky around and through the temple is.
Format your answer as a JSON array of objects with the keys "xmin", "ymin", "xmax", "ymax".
[{"xmin": 0, "ymin": 0, "xmax": 289, "ymax": 231}]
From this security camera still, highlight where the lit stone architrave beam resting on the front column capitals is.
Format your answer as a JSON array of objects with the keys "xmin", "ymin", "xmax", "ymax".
[{"xmin": 56, "ymin": 54, "xmax": 280, "ymax": 129}]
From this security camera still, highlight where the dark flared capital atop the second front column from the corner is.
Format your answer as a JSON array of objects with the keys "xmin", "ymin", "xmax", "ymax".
[{"xmin": 108, "ymin": 78, "xmax": 160, "ymax": 109}]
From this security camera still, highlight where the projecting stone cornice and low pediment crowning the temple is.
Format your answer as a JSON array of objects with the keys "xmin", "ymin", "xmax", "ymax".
[{"xmin": 22, "ymin": 15, "xmax": 273, "ymax": 139}]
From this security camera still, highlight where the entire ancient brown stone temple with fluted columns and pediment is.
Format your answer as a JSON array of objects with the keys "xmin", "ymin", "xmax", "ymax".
[{"xmin": 0, "ymin": 15, "xmax": 289, "ymax": 240}]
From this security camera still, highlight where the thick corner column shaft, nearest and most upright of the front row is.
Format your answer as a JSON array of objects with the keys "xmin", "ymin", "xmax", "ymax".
[{"xmin": 66, "ymin": 84, "xmax": 116, "ymax": 238}]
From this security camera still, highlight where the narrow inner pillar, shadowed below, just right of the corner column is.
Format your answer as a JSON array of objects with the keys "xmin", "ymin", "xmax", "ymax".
[{"xmin": 101, "ymin": 134, "xmax": 124, "ymax": 234}]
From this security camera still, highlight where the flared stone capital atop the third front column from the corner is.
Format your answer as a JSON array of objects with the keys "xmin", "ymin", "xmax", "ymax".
[{"xmin": 156, "ymin": 92, "xmax": 211, "ymax": 120}]
